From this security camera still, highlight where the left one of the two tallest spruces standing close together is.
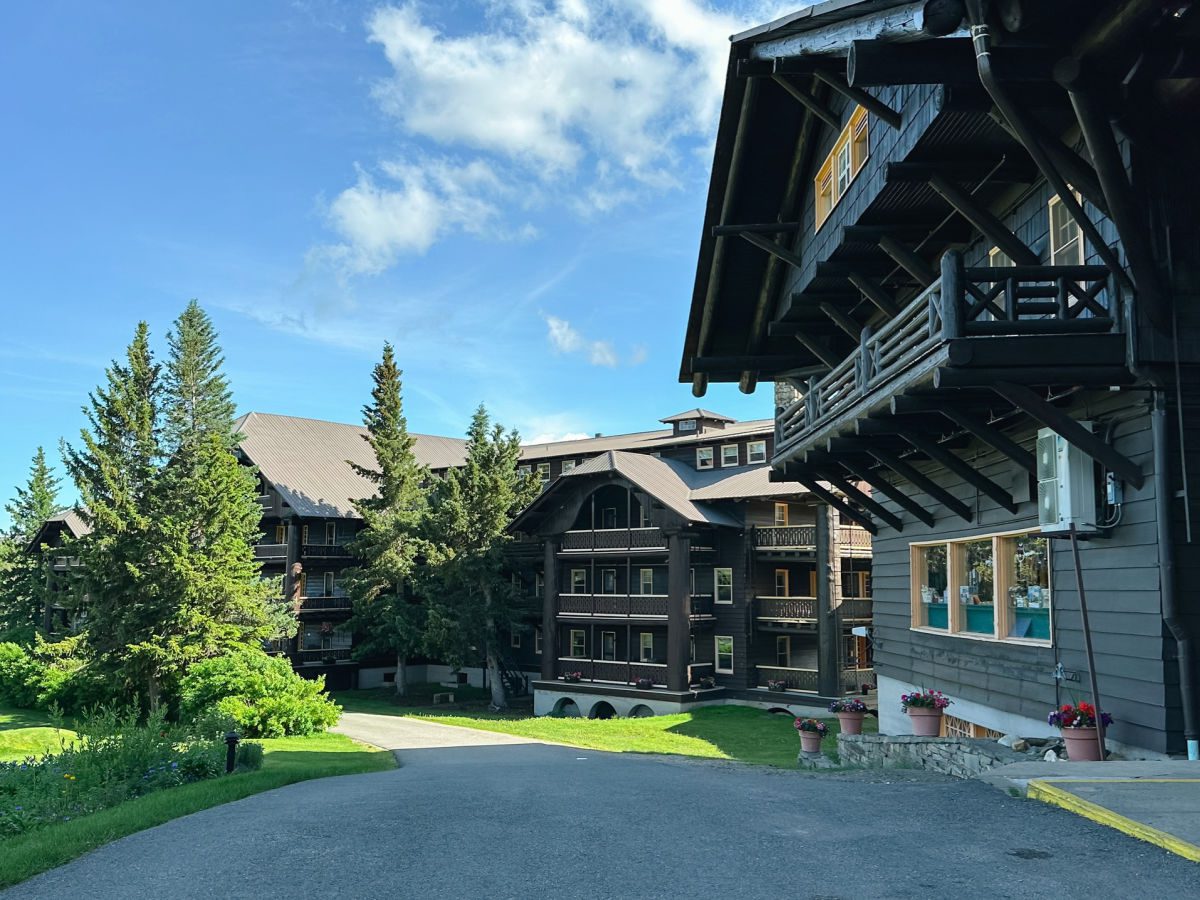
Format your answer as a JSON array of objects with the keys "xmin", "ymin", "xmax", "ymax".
[{"xmin": 62, "ymin": 322, "xmax": 167, "ymax": 702}]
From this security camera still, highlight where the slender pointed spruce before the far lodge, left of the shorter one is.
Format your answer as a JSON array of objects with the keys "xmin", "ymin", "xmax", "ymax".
[{"xmin": 344, "ymin": 343, "xmax": 430, "ymax": 696}]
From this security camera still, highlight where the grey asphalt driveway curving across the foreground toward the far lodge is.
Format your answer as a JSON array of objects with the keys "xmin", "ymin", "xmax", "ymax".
[{"xmin": 5, "ymin": 716, "xmax": 1200, "ymax": 900}]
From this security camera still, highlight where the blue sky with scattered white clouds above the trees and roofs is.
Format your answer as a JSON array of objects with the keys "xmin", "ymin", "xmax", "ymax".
[{"xmin": 0, "ymin": 0, "xmax": 782, "ymax": 511}]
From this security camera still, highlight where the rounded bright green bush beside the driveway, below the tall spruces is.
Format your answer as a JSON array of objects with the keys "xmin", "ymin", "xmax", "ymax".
[{"xmin": 179, "ymin": 650, "xmax": 342, "ymax": 738}]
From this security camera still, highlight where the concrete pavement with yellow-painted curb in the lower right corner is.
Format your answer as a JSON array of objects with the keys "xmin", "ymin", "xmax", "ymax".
[{"xmin": 984, "ymin": 760, "xmax": 1200, "ymax": 863}]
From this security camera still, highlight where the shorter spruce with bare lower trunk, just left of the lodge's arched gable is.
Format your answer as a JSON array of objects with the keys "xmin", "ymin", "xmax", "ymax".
[{"xmin": 430, "ymin": 404, "xmax": 539, "ymax": 708}]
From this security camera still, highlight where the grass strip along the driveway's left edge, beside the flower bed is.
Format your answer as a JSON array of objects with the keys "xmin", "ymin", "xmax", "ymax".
[{"xmin": 0, "ymin": 709, "xmax": 395, "ymax": 888}]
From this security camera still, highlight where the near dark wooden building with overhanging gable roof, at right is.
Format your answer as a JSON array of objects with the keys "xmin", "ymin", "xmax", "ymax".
[{"xmin": 686, "ymin": 0, "xmax": 1200, "ymax": 758}]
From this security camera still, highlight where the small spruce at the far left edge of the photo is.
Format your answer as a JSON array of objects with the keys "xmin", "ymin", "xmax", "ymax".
[{"xmin": 0, "ymin": 448, "xmax": 62, "ymax": 642}]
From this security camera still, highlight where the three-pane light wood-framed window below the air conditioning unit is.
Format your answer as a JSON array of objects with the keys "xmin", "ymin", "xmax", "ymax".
[{"xmin": 910, "ymin": 532, "xmax": 1052, "ymax": 643}]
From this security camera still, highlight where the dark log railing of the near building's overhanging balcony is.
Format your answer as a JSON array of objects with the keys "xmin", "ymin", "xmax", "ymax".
[{"xmin": 775, "ymin": 251, "xmax": 1121, "ymax": 460}]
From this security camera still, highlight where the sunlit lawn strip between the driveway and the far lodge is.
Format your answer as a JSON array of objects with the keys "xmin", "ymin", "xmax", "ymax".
[{"xmin": 336, "ymin": 691, "xmax": 877, "ymax": 768}]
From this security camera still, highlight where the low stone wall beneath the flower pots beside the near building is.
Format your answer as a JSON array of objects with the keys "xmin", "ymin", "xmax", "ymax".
[{"xmin": 838, "ymin": 734, "xmax": 1034, "ymax": 778}]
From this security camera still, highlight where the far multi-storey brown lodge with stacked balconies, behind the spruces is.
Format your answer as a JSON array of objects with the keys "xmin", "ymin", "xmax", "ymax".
[{"xmin": 238, "ymin": 409, "xmax": 874, "ymax": 715}]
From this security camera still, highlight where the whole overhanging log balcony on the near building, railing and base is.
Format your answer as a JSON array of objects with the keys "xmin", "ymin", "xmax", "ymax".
[{"xmin": 773, "ymin": 252, "xmax": 1129, "ymax": 466}]
